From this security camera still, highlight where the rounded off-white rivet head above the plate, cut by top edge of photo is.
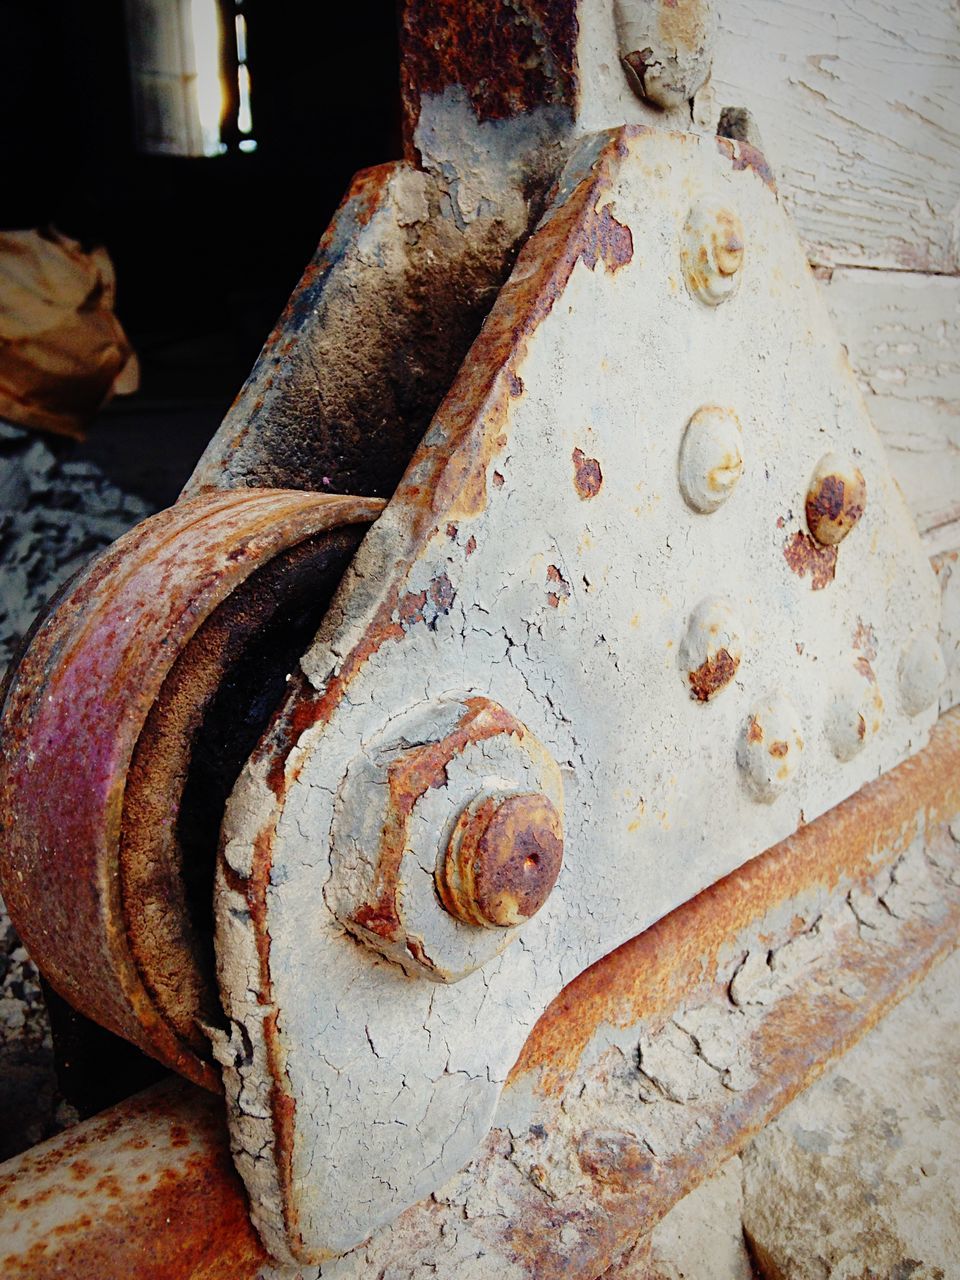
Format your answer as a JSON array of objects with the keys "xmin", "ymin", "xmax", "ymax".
[{"xmin": 614, "ymin": 0, "xmax": 717, "ymax": 109}]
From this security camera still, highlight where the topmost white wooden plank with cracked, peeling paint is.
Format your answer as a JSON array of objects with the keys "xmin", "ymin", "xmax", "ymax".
[{"xmin": 698, "ymin": 0, "xmax": 960, "ymax": 271}]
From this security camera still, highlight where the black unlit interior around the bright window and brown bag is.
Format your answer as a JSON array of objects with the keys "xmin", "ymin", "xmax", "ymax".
[{"xmin": 0, "ymin": 0, "xmax": 401, "ymax": 504}]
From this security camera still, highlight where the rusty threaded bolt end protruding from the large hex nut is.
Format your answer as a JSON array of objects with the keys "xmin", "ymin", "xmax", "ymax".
[{"xmin": 436, "ymin": 791, "xmax": 563, "ymax": 929}]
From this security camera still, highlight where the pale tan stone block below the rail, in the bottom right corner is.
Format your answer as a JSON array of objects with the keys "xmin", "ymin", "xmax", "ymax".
[{"xmin": 747, "ymin": 954, "xmax": 960, "ymax": 1280}]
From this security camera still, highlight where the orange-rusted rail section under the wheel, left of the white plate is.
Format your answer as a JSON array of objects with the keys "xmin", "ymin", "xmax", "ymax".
[{"xmin": 0, "ymin": 1082, "xmax": 266, "ymax": 1280}]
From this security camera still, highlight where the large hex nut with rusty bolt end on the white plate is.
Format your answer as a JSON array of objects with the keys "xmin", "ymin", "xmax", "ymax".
[{"xmin": 328, "ymin": 696, "xmax": 563, "ymax": 982}]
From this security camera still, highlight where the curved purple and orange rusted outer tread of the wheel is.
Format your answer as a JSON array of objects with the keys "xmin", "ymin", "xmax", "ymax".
[{"xmin": 0, "ymin": 490, "xmax": 383, "ymax": 1088}]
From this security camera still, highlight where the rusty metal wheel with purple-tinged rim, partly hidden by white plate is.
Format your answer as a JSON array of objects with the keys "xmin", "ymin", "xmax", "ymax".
[{"xmin": 0, "ymin": 490, "xmax": 383, "ymax": 1089}]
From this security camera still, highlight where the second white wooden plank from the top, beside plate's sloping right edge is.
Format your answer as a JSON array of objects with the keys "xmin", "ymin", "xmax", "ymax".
[{"xmin": 820, "ymin": 267, "xmax": 960, "ymax": 550}]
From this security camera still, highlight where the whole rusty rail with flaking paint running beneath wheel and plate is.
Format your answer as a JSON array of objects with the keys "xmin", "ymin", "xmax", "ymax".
[{"xmin": 0, "ymin": 712, "xmax": 960, "ymax": 1280}]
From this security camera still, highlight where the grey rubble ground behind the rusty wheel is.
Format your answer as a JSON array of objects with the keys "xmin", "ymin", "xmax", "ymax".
[{"xmin": 0, "ymin": 420, "xmax": 150, "ymax": 1160}]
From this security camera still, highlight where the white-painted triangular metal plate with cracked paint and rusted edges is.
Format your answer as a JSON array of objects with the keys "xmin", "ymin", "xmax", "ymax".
[{"xmin": 215, "ymin": 128, "xmax": 938, "ymax": 1261}]
